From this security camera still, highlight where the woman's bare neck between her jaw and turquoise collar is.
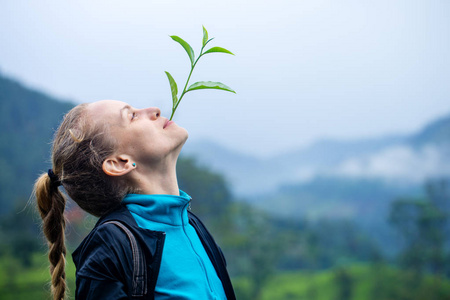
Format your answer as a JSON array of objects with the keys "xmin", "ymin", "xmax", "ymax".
[{"xmin": 133, "ymin": 156, "xmax": 180, "ymax": 196}]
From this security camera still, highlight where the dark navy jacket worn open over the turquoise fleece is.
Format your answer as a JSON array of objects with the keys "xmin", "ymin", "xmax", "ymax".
[{"xmin": 72, "ymin": 206, "xmax": 236, "ymax": 300}]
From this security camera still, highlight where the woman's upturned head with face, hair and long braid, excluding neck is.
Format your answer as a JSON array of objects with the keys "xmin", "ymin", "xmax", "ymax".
[{"xmin": 35, "ymin": 100, "xmax": 187, "ymax": 299}]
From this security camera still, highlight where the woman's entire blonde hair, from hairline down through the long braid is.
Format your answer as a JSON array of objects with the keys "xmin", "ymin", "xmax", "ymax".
[{"xmin": 34, "ymin": 104, "xmax": 133, "ymax": 300}]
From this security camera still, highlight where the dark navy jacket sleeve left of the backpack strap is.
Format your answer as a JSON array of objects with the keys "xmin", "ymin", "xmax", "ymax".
[{"xmin": 75, "ymin": 224, "xmax": 132, "ymax": 300}]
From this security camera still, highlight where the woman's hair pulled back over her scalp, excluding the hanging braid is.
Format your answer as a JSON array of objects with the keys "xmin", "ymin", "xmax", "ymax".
[{"xmin": 52, "ymin": 104, "xmax": 127, "ymax": 216}]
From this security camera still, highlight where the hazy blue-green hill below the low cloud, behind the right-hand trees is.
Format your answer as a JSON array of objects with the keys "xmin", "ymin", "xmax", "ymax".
[{"xmin": 253, "ymin": 177, "xmax": 422, "ymax": 258}]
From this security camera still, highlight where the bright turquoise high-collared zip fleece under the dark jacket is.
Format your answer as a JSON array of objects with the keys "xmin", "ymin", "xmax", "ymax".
[{"xmin": 123, "ymin": 190, "xmax": 226, "ymax": 299}]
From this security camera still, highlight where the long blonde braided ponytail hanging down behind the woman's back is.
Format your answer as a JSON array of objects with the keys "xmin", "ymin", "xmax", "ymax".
[{"xmin": 34, "ymin": 174, "xmax": 67, "ymax": 300}]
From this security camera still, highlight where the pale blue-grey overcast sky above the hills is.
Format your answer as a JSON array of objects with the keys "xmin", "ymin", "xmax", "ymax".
[{"xmin": 0, "ymin": 0, "xmax": 450, "ymax": 157}]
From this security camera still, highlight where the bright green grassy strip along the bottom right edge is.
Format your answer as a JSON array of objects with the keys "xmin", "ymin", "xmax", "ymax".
[{"xmin": 233, "ymin": 264, "xmax": 450, "ymax": 300}]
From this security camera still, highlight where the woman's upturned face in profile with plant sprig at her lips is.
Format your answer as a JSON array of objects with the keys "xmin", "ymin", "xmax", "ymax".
[{"xmin": 88, "ymin": 100, "xmax": 188, "ymax": 165}]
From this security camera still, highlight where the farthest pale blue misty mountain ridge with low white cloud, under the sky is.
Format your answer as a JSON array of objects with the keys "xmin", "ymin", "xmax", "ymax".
[{"xmin": 182, "ymin": 115, "xmax": 450, "ymax": 196}]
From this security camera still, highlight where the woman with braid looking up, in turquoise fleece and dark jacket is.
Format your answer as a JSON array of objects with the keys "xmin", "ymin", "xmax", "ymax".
[{"xmin": 35, "ymin": 100, "xmax": 235, "ymax": 300}]
